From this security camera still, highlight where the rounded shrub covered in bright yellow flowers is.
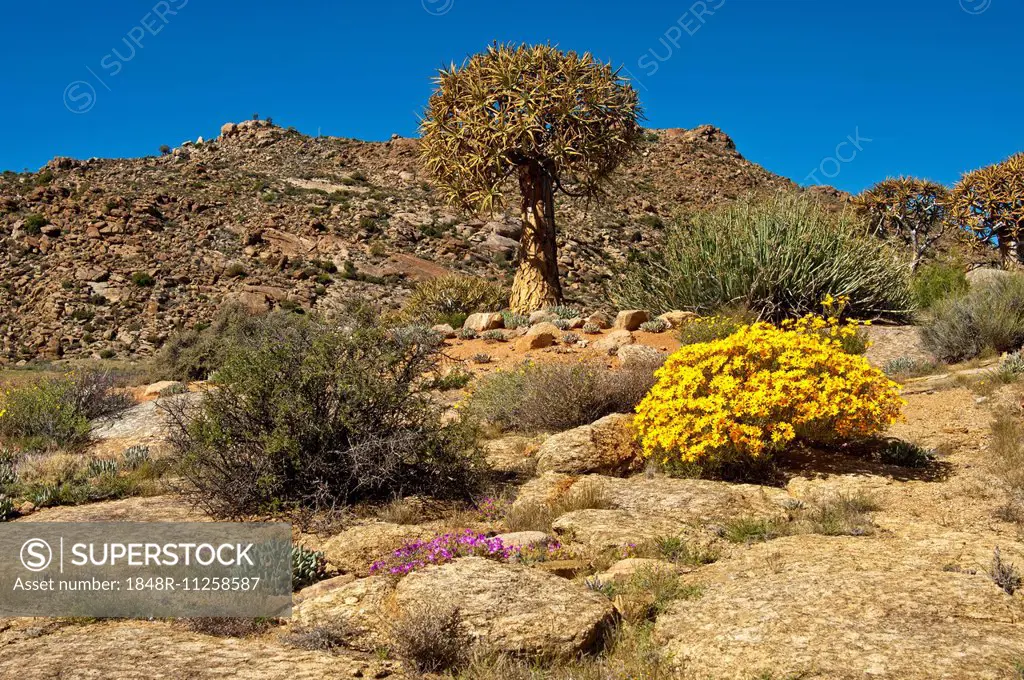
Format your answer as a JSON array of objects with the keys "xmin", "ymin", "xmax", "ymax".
[{"xmin": 634, "ymin": 316, "xmax": 903, "ymax": 463}]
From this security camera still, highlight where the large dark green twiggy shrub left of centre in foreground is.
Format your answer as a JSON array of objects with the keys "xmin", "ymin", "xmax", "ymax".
[{"xmin": 168, "ymin": 312, "xmax": 479, "ymax": 517}]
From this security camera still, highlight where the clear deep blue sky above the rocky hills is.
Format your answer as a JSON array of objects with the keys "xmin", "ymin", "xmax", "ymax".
[{"xmin": 0, "ymin": 0, "xmax": 1024, "ymax": 192}]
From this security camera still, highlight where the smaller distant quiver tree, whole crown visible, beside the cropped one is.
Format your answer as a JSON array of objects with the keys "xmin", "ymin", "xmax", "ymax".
[{"xmin": 853, "ymin": 177, "xmax": 947, "ymax": 269}]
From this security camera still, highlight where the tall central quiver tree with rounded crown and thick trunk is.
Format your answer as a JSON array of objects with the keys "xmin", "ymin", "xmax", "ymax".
[{"xmin": 421, "ymin": 45, "xmax": 642, "ymax": 312}]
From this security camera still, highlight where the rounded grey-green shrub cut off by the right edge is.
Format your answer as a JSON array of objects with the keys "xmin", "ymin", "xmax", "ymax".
[{"xmin": 921, "ymin": 274, "xmax": 1024, "ymax": 362}]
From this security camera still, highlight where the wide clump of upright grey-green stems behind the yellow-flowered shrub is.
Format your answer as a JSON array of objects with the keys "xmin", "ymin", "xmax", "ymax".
[{"xmin": 613, "ymin": 196, "xmax": 913, "ymax": 321}]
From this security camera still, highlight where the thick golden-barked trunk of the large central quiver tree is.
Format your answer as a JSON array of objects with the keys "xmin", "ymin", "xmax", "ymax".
[{"xmin": 509, "ymin": 163, "xmax": 562, "ymax": 313}]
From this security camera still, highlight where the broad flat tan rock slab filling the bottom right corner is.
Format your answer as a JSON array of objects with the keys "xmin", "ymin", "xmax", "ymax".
[{"xmin": 655, "ymin": 536, "xmax": 1024, "ymax": 680}]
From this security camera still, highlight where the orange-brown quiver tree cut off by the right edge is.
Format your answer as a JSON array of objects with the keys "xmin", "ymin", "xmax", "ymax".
[{"xmin": 946, "ymin": 154, "xmax": 1024, "ymax": 264}]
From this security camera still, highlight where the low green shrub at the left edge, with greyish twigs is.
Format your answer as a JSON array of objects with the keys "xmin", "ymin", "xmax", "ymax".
[{"xmin": 0, "ymin": 371, "xmax": 132, "ymax": 450}]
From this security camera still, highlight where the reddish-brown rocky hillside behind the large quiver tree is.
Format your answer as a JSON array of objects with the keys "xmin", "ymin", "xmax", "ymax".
[{"xmin": 0, "ymin": 121, "xmax": 799, "ymax": 365}]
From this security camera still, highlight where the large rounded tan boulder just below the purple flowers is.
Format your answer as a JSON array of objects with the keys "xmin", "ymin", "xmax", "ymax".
[{"xmin": 394, "ymin": 557, "xmax": 615, "ymax": 660}]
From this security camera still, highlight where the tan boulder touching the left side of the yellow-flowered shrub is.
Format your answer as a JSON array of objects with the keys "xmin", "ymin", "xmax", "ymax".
[{"xmin": 537, "ymin": 413, "xmax": 636, "ymax": 474}]
